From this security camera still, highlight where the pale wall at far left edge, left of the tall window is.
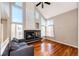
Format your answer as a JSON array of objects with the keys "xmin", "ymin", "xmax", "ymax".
[{"xmin": 1, "ymin": 3, "xmax": 11, "ymax": 55}]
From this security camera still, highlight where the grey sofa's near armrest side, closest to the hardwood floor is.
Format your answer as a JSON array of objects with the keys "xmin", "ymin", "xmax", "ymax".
[{"xmin": 10, "ymin": 45, "xmax": 34, "ymax": 56}]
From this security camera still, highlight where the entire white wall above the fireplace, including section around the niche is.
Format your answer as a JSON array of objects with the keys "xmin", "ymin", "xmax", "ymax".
[{"xmin": 24, "ymin": 2, "xmax": 41, "ymax": 30}]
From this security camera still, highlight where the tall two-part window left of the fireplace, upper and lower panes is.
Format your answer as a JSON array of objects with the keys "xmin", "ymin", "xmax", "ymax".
[{"xmin": 11, "ymin": 2, "xmax": 23, "ymax": 39}]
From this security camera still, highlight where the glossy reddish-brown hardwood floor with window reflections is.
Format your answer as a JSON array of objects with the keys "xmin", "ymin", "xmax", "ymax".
[{"xmin": 30, "ymin": 40, "xmax": 78, "ymax": 56}]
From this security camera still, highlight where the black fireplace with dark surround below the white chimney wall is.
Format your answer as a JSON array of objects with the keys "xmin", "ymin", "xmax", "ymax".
[{"xmin": 24, "ymin": 30, "xmax": 41, "ymax": 42}]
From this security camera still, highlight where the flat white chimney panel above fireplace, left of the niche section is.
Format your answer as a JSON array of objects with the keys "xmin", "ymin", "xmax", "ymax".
[{"xmin": 24, "ymin": 2, "xmax": 35, "ymax": 30}]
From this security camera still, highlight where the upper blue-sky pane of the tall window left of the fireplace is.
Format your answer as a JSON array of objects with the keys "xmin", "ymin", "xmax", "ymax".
[{"xmin": 12, "ymin": 6, "xmax": 23, "ymax": 23}]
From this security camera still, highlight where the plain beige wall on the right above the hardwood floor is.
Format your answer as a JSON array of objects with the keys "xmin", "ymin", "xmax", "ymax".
[{"xmin": 52, "ymin": 9, "xmax": 78, "ymax": 47}]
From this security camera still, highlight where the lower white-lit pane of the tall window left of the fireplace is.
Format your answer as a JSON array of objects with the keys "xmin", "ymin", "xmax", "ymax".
[{"xmin": 11, "ymin": 23, "xmax": 23, "ymax": 39}]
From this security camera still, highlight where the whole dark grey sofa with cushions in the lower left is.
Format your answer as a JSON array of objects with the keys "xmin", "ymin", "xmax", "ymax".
[{"xmin": 3, "ymin": 40, "xmax": 34, "ymax": 56}]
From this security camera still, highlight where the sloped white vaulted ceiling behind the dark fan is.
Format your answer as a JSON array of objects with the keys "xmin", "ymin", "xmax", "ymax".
[{"xmin": 35, "ymin": 2, "xmax": 77, "ymax": 19}]
